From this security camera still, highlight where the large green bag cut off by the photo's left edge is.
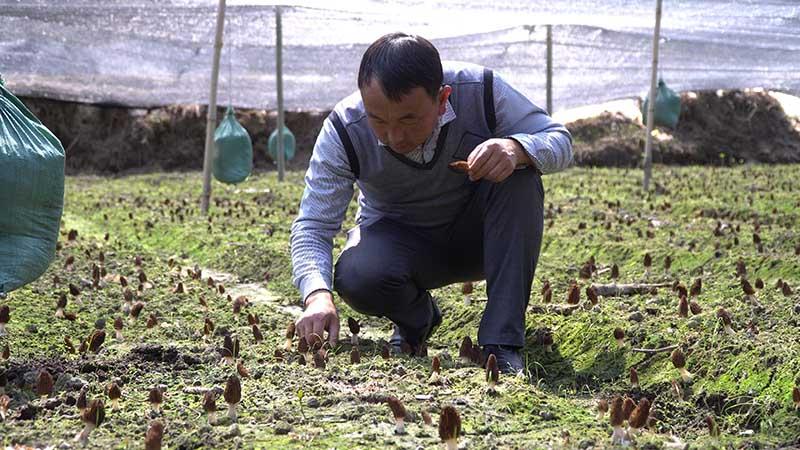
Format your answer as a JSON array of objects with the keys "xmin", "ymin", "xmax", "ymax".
[{"xmin": 0, "ymin": 79, "xmax": 65, "ymax": 293}]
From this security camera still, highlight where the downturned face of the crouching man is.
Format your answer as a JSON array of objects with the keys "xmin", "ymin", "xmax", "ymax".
[{"xmin": 361, "ymin": 79, "xmax": 451, "ymax": 154}]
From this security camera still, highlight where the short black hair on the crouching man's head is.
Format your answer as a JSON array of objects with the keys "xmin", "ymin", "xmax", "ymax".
[{"xmin": 358, "ymin": 33, "xmax": 444, "ymax": 102}]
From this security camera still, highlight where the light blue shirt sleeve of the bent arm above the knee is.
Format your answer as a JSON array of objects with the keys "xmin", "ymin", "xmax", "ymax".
[{"xmin": 492, "ymin": 72, "xmax": 572, "ymax": 174}]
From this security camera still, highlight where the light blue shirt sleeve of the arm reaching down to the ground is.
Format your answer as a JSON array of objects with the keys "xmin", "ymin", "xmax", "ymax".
[{"xmin": 290, "ymin": 119, "xmax": 355, "ymax": 301}]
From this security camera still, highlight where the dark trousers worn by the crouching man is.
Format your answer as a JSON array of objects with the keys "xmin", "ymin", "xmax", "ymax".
[{"xmin": 334, "ymin": 168, "xmax": 544, "ymax": 347}]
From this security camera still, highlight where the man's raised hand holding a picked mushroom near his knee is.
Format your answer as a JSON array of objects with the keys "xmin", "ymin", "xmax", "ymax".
[{"xmin": 467, "ymin": 139, "xmax": 531, "ymax": 183}]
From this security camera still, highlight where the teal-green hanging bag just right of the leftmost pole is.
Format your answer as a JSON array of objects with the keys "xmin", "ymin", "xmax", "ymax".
[{"xmin": 213, "ymin": 106, "xmax": 253, "ymax": 184}]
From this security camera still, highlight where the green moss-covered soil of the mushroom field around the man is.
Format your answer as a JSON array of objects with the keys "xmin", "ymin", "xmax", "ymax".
[{"xmin": 0, "ymin": 166, "xmax": 800, "ymax": 448}]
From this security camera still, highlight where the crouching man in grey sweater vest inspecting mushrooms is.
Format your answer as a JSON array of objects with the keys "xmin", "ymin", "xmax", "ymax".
[{"xmin": 291, "ymin": 33, "xmax": 572, "ymax": 372}]
